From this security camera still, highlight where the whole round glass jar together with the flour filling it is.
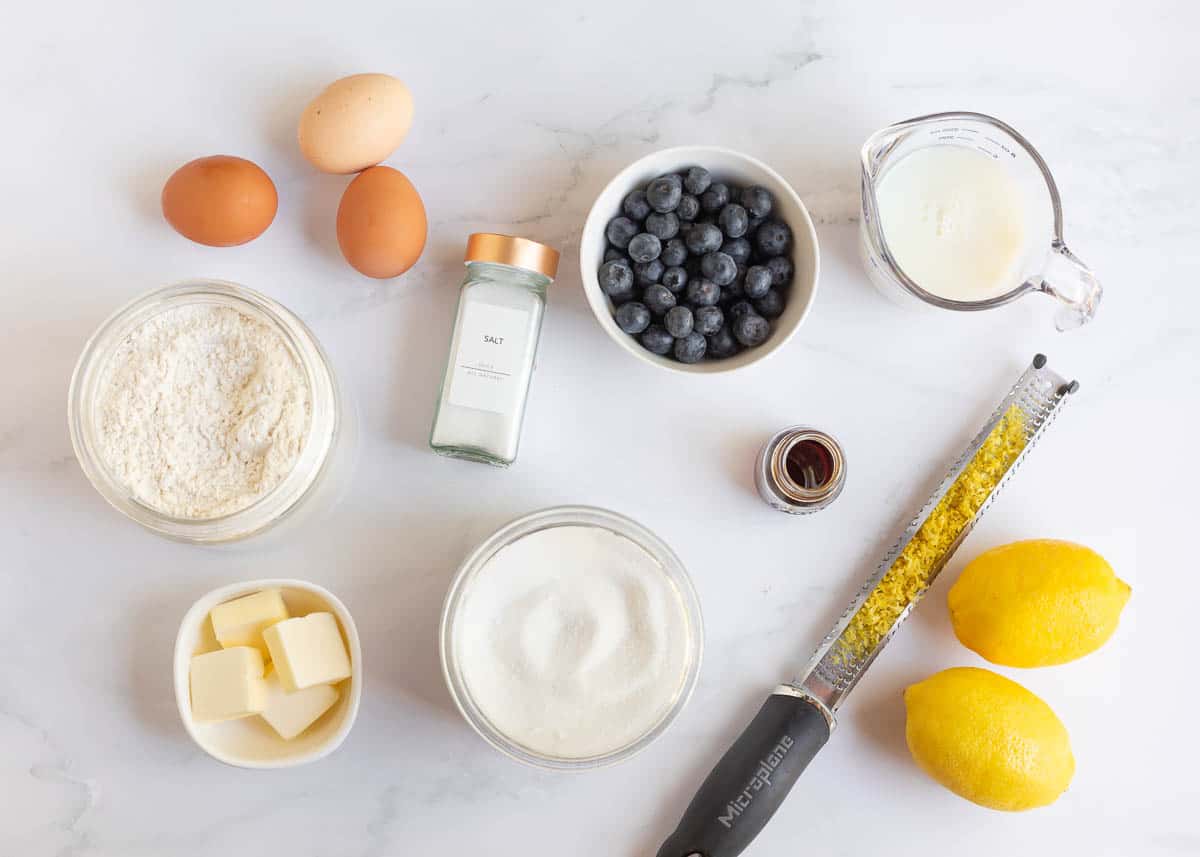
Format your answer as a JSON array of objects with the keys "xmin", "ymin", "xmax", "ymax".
[{"xmin": 67, "ymin": 280, "xmax": 345, "ymax": 545}]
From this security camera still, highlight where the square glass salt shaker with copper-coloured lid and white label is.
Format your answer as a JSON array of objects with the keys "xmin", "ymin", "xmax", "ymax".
[{"xmin": 430, "ymin": 233, "xmax": 558, "ymax": 467}]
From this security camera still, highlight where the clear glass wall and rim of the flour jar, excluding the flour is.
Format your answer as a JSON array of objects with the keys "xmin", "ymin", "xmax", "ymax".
[{"xmin": 67, "ymin": 280, "xmax": 353, "ymax": 544}]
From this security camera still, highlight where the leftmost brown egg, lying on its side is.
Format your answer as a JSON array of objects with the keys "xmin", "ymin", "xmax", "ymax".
[{"xmin": 162, "ymin": 155, "xmax": 280, "ymax": 247}]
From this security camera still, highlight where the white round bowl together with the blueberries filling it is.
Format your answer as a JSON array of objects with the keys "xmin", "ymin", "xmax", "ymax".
[{"xmin": 580, "ymin": 146, "xmax": 818, "ymax": 373}]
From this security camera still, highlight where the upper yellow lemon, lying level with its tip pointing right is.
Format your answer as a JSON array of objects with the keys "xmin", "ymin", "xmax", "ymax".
[{"xmin": 946, "ymin": 539, "xmax": 1129, "ymax": 666}]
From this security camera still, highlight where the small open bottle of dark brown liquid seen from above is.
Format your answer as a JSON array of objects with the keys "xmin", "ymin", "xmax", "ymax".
[{"xmin": 755, "ymin": 426, "xmax": 846, "ymax": 515}]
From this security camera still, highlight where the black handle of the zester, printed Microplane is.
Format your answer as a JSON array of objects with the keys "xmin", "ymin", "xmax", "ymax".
[{"xmin": 658, "ymin": 694, "xmax": 829, "ymax": 857}]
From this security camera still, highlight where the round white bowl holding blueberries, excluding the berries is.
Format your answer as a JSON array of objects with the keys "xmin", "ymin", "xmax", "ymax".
[{"xmin": 580, "ymin": 145, "xmax": 820, "ymax": 374}]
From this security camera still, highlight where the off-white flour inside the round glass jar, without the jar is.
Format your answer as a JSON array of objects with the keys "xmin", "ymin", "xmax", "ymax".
[{"xmin": 96, "ymin": 304, "xmax": 311, "ymax": 520}]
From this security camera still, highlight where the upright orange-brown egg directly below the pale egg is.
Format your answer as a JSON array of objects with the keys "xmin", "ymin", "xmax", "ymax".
[{"xmin": 337, "ymin": 167, "xmax": 427, "ymax": 280}]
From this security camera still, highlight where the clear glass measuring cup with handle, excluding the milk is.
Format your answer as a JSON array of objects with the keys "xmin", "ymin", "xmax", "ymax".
[{"xmin": 859, "ymin": 112, "xmax": 1103, "ymax": 330}]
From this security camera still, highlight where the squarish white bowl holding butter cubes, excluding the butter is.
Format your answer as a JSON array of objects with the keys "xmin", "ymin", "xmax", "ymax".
[{"xmin": 175, "ymin": 579, "xmax": 362, "ymax": 768}]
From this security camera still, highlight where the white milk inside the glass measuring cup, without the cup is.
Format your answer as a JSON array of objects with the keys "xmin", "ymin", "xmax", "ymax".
[{"xmin": 876, "ymin": 145, "xmax": 1028, "ymax": 301}]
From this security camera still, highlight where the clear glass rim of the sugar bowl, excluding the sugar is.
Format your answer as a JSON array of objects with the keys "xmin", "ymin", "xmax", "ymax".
[{"xmin": 439, "ymin": 505, "xmax": 704, "ymax": 771}]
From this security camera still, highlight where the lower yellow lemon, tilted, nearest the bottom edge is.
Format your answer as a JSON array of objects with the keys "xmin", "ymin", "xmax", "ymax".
[{"xmin": 904, "ymin": 666, "xmax": 1075, "ymax": 811}]
